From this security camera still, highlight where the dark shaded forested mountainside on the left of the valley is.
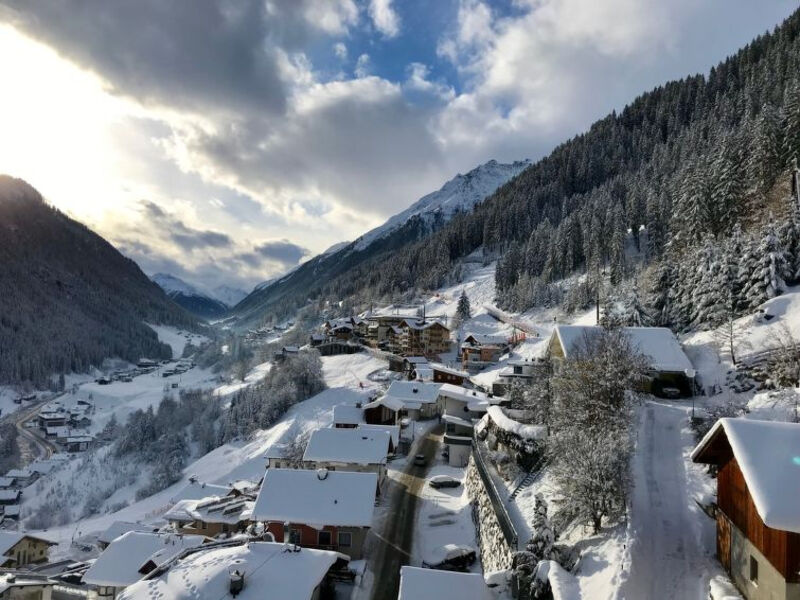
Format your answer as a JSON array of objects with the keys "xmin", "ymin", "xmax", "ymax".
[{"xmin": 0, "ymin": 176, "xmax": 197, "ymax": 384}]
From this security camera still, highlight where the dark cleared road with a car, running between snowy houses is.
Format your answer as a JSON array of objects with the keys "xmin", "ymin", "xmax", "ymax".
[{"xmin": 369, "ymin": 425, "xmax": 444, "ymax": 600}]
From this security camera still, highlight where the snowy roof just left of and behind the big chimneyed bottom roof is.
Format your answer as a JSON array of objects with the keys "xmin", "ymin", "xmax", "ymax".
[{"xmin": 83, "ymin": 531, "xmax": 206, "ymax": 587}]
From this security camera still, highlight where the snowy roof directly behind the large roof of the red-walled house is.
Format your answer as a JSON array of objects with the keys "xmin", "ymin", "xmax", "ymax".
[{"xmin": 303, "ymin": 428, "xmax": 390, "ymax": 465}]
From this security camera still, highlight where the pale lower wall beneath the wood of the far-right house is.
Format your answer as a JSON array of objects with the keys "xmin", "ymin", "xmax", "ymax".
[{"xmin": 731, "ymin": 523, "xmax": 800, "ymax": 600}]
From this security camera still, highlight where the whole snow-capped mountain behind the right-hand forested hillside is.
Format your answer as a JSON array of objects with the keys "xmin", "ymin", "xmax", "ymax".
[{"xmin": 231, "ymin": 160, "xmax": 530, "ymax": 327}]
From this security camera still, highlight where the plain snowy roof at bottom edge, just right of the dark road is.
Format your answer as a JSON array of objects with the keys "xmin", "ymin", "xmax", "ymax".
[{"xmin": 397, "ymin": 567, "xmax": 492, "ymax": 600}]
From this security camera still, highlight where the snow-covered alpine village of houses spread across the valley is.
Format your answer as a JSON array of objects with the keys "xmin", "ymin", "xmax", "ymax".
[{"xmin": 0, "ymin": 268, "xmax": 800, "ymax": 600}]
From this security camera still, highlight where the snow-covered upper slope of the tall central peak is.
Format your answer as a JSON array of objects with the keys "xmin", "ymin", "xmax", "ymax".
[{"xmin": 355, "ymin": 160, "xmax": 530, "ymax": 250}]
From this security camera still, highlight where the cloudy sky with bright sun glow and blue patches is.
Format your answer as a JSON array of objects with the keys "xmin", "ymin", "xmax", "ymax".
[{"xmin": 0, "ymin": 0, "xmax": 796, "ymax": 289}]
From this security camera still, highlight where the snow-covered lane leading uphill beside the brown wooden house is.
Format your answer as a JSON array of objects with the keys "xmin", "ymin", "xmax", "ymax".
[{"xmin": 618, "ymin": 402, "xmax": 713, "ymax": 600}]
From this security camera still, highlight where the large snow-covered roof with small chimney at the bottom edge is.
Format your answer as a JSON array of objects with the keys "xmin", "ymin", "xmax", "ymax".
[{"xmin": 118, "ymin": 542, "xmax": 344, "ymax": 600}]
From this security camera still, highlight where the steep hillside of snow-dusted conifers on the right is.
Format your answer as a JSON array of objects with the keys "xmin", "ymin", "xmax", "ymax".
[{"xmin": 234, "ymin": 8, "xmax": 800, "ymax": 328}]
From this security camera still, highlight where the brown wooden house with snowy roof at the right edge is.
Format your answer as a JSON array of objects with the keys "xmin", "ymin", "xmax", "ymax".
[{"xmin": 692, "ymin": 419, "xmax": 800, "ymax": 600}]
